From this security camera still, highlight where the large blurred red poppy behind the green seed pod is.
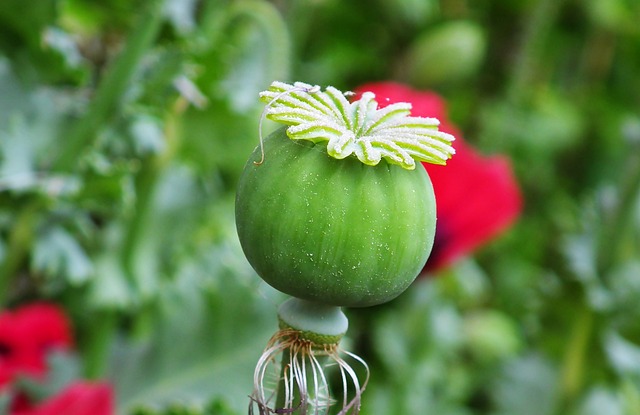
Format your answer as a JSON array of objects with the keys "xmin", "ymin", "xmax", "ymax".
[{"xmin": 356, "ymin": 82, "xmax": 522, "ymax": 272}]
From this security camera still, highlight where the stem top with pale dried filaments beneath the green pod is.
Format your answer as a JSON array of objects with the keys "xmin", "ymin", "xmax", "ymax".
[{"xmin": 249, "ymin": 298, "xmax": 369, "ymax": 415}]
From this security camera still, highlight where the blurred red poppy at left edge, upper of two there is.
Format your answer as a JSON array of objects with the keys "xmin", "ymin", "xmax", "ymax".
[{"xmin": 0, "ymin": 303, "xmax": 73, "ymax": 387}]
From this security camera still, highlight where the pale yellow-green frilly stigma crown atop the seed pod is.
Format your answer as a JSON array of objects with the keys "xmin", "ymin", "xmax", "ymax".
[{"xmin": 260, "ymin": 82, "xmax": 455, "ymax": 170}]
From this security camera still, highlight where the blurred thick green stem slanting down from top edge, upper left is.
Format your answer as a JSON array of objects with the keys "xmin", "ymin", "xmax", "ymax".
[{"xmin": 53, "ymin": 0, "xmax": 164, "ymax": 170}]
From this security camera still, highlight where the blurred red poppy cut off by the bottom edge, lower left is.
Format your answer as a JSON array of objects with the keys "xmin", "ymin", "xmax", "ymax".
[{"xmin": 12, "ymin": 382, "xmax": 115, "ymax": 415}]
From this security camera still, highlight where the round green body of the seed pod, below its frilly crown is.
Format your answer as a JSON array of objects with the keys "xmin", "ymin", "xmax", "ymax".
[{"xmin": 236, "ymin": 128, "xmax": 436, "ymax": 307}]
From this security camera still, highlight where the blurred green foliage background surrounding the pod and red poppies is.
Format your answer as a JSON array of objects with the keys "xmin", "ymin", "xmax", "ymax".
[{"xmin": 0, "ymin": 0, "xmax": 640, "ymax": 415}]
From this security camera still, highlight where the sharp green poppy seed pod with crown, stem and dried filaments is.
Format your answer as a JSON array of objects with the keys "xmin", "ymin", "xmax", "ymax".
[{"xmin": 242, "ymin": 81, "xmax": 454, "ymax": 415}]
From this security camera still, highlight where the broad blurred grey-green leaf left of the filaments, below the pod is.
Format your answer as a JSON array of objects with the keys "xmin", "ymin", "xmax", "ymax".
[{"xmin": 109, "ymin": 241, "xmax": 277, "ymax": 412}]
